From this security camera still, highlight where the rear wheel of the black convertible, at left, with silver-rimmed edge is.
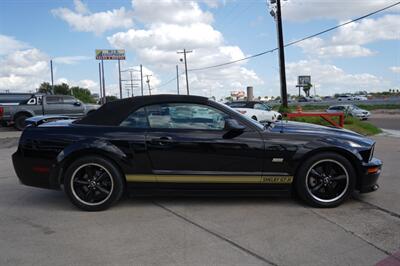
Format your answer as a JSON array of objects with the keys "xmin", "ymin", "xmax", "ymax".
[{"xmin": 64, "ymin": 155, "xmax": 125, "ymax": 211}]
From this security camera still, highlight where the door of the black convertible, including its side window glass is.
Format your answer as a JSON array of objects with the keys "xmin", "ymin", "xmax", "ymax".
[{"xmin": 142, "ymin": 103, "xmax": 264, "ymax": 183}]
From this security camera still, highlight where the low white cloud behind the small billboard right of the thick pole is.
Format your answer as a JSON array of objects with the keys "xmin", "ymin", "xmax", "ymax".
[{"xmin": 286, "ymin": 60, "xmax": 389, "ymax": 95}]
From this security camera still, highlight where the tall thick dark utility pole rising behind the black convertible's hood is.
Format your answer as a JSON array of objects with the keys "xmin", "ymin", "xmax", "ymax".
[{"xmin": 270, "ymin": 0, "xmax": 288, "ymax": 108}]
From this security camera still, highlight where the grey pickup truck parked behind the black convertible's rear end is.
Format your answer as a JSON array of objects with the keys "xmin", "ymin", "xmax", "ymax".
[{"xmin": 0, "ymin": 95, "xmax": 99, "ymax": 130}]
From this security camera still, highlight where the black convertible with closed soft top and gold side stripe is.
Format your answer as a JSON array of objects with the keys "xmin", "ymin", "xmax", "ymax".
[{"xmin": 13, "ymin": 95, "xmax": 382, "ymax": 211}]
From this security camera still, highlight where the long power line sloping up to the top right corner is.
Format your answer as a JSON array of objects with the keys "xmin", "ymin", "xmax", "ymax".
[{"xmin": 188, "ymin": 2, "xmax": 400, "ymax": 71}]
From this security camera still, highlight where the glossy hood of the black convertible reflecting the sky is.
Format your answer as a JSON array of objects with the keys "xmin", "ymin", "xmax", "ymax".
[{"xmin": 271, "ymin": 120, "xmax": 374, "ymax": 145}]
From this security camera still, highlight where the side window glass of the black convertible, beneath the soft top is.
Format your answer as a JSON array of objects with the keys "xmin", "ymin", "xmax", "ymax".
[{"xmin": 146, "ymin": 103, "xmax": 228, "ymax": 130}]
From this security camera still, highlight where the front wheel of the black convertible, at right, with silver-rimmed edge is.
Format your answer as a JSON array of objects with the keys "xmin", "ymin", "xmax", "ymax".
[{"xmin": 295, "ymin": 152, "xmax": 356, "ymax": 208}]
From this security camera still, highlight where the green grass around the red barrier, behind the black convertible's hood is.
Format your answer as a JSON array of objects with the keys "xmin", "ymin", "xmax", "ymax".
[{"xmin": 292, "ymin": 116, "xmax": 382, "ymax": 136}]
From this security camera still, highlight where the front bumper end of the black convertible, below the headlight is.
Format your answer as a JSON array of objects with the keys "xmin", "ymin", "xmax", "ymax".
[{"xmin": 357, "ymin": 158, "xmax": 382, "ymax": 193}]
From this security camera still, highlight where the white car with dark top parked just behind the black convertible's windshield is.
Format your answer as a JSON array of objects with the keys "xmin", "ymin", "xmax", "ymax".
[{"xmin": 226, "ymin": 101, "xmax": 282, "ymax": 123}]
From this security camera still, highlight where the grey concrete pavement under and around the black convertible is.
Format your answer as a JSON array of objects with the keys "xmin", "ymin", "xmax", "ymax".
[{"xmin": 0, "ymin": 136, "xmax": 400, "ymax": 265}]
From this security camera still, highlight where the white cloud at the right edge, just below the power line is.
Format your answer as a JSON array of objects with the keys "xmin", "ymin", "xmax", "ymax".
[{"xmin": 297, "ymin": 15, "xmax": 400, "ymax": 58}]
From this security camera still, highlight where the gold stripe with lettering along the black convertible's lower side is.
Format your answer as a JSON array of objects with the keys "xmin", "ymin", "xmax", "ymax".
[{"xmin": 126, "ymin": 175, "xmax": 293, "ymax": 184}]
